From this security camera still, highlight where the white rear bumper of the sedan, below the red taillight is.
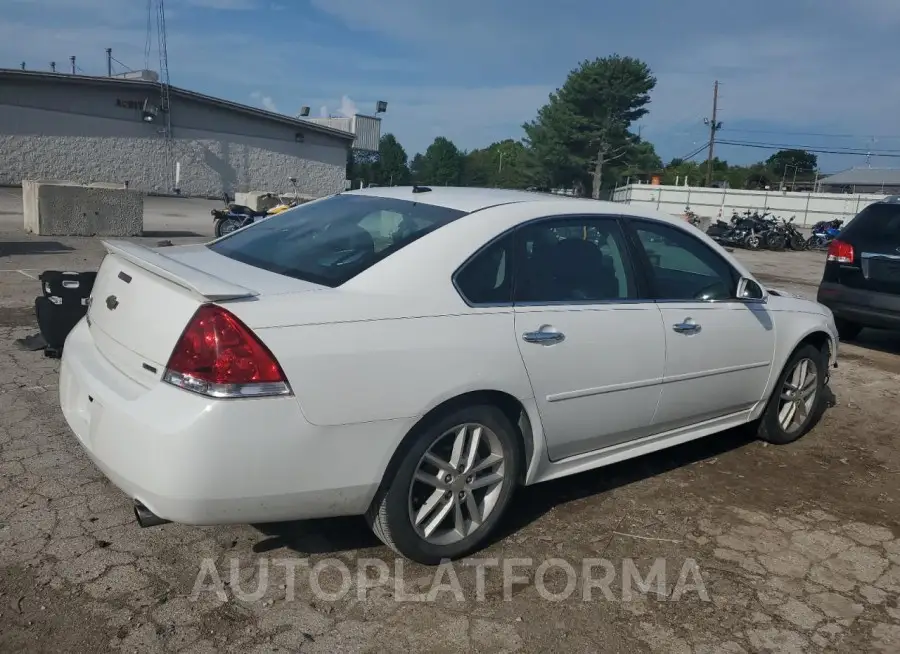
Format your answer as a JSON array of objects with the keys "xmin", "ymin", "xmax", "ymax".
[{"xmin": 59, "ymin": 321, "xmax": 406, "ymax": 525}]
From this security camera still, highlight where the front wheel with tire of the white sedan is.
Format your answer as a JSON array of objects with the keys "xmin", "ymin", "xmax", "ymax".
[{"xmin": 757, "ymin": 344, "xmax": 827, "ymax": 445}]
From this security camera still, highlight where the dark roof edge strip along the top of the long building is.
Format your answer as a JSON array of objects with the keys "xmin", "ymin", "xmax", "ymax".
[{"xmin": 0, "ymin": 68, "xmax": 356, "ymax": 141}]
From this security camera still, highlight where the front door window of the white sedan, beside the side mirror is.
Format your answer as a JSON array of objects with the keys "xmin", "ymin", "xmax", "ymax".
[{"xmin": 633, "ymin": 221, "xmax": 738, "ymax": 302}]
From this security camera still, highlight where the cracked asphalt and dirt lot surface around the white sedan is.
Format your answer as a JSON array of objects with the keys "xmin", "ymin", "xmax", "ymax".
[{"xmin": 0, "ymin": 189, "xmax": 900, "ymax": 654}]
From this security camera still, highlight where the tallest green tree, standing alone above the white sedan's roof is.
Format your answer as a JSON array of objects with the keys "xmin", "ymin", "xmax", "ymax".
[{"xmin": 523, "ymin": 55, "xmax": 656, "ymax": 198}]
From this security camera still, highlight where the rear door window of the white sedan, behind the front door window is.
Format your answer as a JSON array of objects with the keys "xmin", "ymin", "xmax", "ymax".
[{"xmin": 515, "ymin": 217, "xmax": 636, "ymax": 303}]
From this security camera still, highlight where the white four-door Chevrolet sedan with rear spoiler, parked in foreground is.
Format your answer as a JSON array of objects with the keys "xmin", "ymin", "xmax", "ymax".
[{"xmin": 59, "ymin": 187, "xmax": 838, "ymax": 563}]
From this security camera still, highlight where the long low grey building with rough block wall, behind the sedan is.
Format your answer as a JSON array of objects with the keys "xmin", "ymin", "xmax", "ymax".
[{"xmin": 0, "ymin": 69, "xmax": 380, "ymax": 197}]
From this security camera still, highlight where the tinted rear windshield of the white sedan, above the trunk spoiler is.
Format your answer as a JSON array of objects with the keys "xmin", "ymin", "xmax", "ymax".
[{"xmin": 208, "ymin": 195, "xmax": 465, "ymax": 288}]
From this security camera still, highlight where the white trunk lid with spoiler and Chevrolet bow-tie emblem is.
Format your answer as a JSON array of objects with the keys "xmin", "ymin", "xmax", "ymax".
[{"xmin": 87, "ymin": 241, "xmax": 315, "ymax": 387}]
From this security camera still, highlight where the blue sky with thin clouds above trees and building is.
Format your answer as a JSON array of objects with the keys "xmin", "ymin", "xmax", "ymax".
[{"xmin": 0, "ymin": 0, "xmax": 900, "ymax": 172}]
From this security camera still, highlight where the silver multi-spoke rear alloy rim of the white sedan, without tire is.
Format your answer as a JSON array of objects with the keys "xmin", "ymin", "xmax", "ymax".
[{"xmin": 409, "ymin": 423, "xmax": 508, "ymax": 545}]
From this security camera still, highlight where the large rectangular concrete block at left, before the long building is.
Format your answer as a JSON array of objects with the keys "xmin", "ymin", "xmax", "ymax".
[{"xmin": 22, "ymin": 180, "xmax": 144, "ymax": 236}]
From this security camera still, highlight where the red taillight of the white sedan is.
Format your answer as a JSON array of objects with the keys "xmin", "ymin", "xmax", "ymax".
[{"xmin": 163, "ymin": 304, "xmax": 291, "ymax": 398}]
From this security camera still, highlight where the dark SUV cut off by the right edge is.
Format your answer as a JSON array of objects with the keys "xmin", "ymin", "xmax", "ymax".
[{"xmin": 817, "ymin": 196, "xmax": 900, "ymax": 339}]
